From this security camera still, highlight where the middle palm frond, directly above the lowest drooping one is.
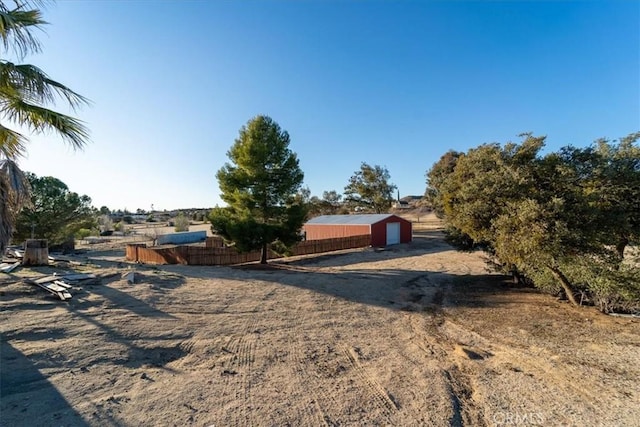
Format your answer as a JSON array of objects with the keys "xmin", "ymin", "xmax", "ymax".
[{"xmin": 0, "ymin": 60, "xmax": 90, "ymax": 110}]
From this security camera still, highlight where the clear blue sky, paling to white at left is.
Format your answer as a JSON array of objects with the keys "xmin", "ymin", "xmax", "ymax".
[{"xmin": 20, "ymin": 0, "xmax": 640, "ymax": 210}]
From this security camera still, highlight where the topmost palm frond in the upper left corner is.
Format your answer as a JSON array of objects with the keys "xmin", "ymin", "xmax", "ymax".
[{"xmin": 0, "ymin": 2, "xmax": 47, "ymax": 57}]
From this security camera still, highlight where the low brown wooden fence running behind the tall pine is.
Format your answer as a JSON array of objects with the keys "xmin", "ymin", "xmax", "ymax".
[{"xmin": 126, "ymin": 234, "xmax": 371, "ymax": 265}]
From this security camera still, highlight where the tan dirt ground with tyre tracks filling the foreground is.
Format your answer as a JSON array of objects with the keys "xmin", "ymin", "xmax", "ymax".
[{"xmin": 0, "ymin": 219, "xmax": 640, "ymax": 426}]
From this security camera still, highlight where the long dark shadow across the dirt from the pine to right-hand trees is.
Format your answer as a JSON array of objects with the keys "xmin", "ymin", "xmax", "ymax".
[{"xmin": 162, "ymin": 254, "xmax": 531, "ymax": 310}]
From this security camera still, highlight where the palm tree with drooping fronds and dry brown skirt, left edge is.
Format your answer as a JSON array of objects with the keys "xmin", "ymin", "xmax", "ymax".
[{"xmin": 0, "ymin": 0, "xmax": 89, "ymax": 254}]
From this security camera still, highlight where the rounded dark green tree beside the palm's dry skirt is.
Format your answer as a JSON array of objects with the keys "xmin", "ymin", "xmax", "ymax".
[{"xmin": 14, "ymin": 173, "xmax": 96, "ymax": 244}]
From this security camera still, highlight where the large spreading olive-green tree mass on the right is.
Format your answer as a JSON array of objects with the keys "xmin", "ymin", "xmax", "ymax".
[{"xmin": 429, "ymin": 134, "xmax": 640, "ymax": 310}]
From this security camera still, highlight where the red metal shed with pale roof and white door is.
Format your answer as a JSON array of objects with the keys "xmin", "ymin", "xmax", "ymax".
[{"xmin": 303, "ymin": 214, "xmax": 412, "ymax": 247}]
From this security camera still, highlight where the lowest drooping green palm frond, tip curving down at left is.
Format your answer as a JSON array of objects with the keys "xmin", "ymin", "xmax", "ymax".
[{"xmin": 0, "ymin": 96, "xmax": 89, "ymax": 149}]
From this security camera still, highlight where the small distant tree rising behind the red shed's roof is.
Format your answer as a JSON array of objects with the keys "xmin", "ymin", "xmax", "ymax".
[{"xmin": 344, "ymin": 162, "xmax": 397, "ymax": 213}]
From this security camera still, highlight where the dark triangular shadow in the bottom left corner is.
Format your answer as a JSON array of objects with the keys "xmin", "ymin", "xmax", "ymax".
[{"xmin": 0, "ymin": 342, "xmax": 89, "ymax": 426}]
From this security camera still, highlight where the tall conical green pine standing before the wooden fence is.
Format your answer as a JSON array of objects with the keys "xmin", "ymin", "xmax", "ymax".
[{"xmin": 209, "ymin": 115, "xmax": 306, "ymax": 264}]
